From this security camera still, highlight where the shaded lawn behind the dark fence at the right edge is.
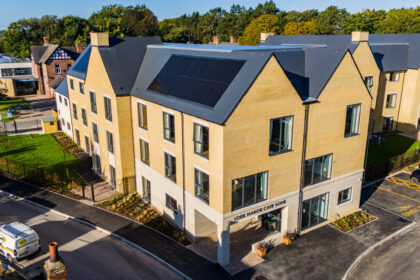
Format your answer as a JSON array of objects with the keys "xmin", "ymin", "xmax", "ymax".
[{"xmin": 367, "ymin": 134, "xmax": 420, "ymax": 166}]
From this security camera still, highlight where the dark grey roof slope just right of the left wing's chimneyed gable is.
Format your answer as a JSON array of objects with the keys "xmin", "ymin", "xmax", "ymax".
[{"xmin": 98, "ymin": 37, "xmax": 162, "ymax": 96}]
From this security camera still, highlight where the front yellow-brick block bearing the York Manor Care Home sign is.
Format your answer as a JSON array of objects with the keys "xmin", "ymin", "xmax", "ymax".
[{"xmin": 129, "ymin": 44, "xmax": 372, "ymax": 265}]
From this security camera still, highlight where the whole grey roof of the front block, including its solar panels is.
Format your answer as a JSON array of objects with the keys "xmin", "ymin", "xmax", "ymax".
[{"xmin": 131, "ymin": 44, "xmax": 347, "ymax": 124}]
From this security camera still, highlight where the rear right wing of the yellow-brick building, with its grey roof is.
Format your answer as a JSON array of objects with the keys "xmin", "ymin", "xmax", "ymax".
[{"xmin": 261, "ymin": 32, "xmax": 420, "ymax": 134}]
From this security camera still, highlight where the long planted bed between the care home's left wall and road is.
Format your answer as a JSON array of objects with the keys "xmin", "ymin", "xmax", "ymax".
[{"xmin": 96, "ymin": 193, "xmax": 190, "ymax": 245}]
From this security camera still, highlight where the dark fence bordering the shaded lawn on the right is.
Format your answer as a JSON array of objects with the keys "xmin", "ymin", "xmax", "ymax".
[{"xmin": 364, "ymin": 149, "xmax": 420, "ymax": 182}]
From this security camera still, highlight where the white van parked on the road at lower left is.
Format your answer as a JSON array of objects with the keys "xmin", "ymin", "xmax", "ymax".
[{"xmin": 0, "ymin": 222, "xmax": 41, "ymax": 260}]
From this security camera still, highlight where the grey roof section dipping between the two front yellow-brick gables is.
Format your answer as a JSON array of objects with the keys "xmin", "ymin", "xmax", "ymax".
[{"xmin": 274, "ymin": 48, "xmax": 347, "ymax": 101}]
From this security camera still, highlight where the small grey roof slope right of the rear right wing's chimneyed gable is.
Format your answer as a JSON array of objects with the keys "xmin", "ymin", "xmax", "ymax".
[{"xmin": 369, "ymin": 43, "xmax": 409, "ymax": 72}]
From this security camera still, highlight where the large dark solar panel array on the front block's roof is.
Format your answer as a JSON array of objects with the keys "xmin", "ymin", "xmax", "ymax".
[{"xmin": 148, "ymin": 55, "xmax": 245, "ymax": 107}]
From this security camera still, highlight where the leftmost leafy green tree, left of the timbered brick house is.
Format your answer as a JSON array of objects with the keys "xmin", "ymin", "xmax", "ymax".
[{"xmin": 4, "ymin": 18, "xmax": 42, "ymax": 57}]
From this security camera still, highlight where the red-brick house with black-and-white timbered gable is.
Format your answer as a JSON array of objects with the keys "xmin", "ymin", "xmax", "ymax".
[{"xmin": 31, "ymin": 38, "xmax": 86, "ymax": 97}]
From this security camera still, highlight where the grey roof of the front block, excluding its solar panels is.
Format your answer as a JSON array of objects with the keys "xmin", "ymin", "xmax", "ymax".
[{"xmin": 131, "ymin": 45, "xmax": 347, "ymax": 124}]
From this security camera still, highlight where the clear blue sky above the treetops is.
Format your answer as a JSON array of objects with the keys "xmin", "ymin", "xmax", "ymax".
[{"xmin": 0, "ymin": 0, "xmax": 420, "ymax": 30}]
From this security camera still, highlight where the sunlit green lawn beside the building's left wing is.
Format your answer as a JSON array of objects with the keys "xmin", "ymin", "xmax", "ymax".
[{"xmin": 0, "ymin": 134, "xmax": 83, "ymax": 184}]
